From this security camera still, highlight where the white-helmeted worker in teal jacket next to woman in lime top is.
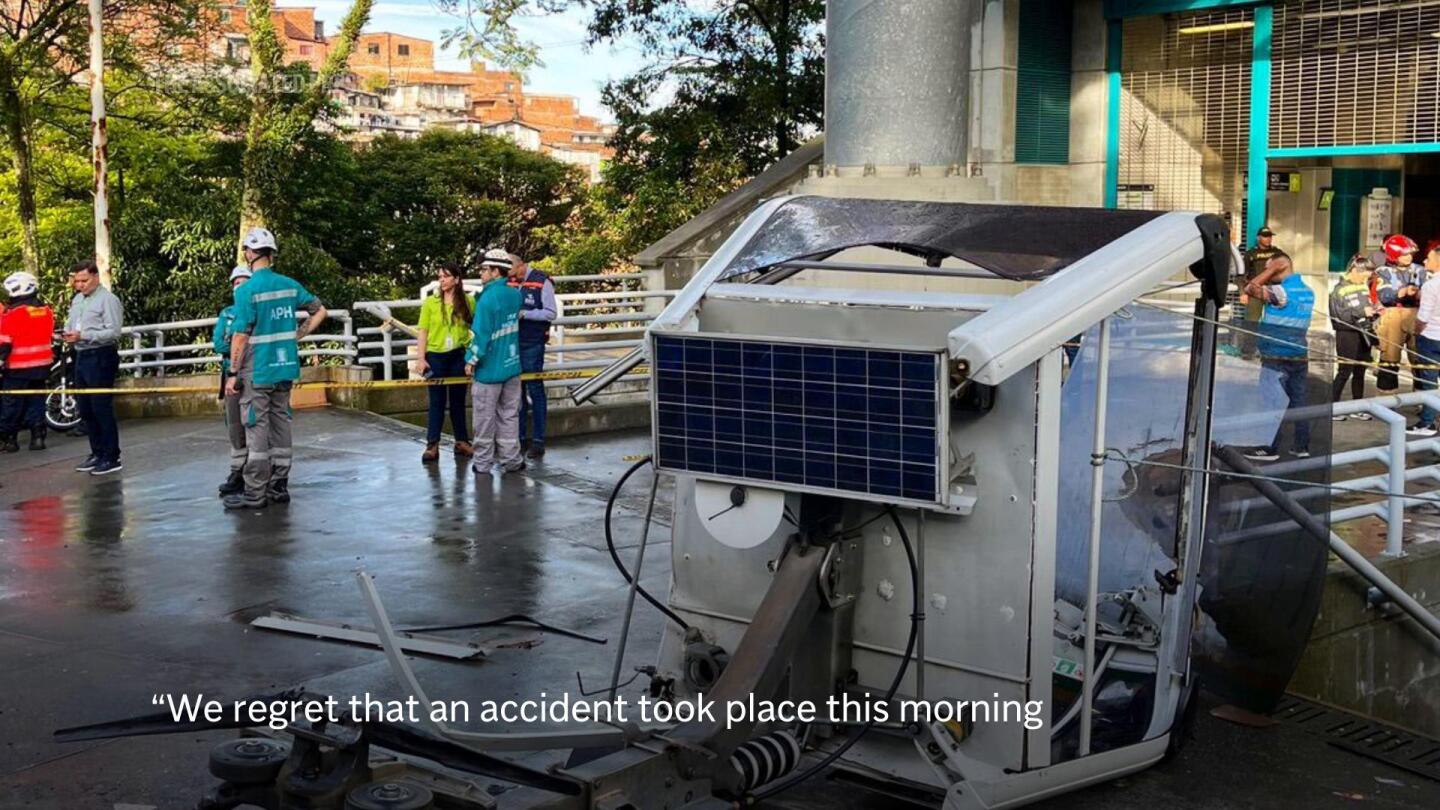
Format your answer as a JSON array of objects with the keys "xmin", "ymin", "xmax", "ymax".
[{"xmin": 465, "ymin": 251, "xmax": 526, "ymax": 473}]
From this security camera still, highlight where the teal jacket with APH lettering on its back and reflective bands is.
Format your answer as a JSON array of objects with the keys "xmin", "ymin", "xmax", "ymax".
[{"xmin": 233, "ymin": 267, "xmax": 320, "ymax": 386}]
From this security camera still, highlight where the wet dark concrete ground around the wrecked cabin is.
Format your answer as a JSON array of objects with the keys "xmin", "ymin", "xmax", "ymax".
[{"xmin": 0, "ymin": 409, "xmax": 1440, "ymax": 810}]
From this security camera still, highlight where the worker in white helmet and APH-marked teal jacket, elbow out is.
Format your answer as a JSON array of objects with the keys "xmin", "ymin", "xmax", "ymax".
[{"xmin": 223, "ymin": 228, "xmax": 325, "ymax": 509}]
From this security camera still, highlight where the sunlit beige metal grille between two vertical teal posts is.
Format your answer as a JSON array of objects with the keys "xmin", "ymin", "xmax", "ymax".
[{"xmin": 1119, "ymin": 9, "xmax": 1254, "ymax": 231}]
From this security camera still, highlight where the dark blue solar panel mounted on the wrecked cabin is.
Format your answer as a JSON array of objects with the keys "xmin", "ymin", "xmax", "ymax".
[{"xmin": 652, "ymin": 334, "xmax": 940, "ymax": 503}]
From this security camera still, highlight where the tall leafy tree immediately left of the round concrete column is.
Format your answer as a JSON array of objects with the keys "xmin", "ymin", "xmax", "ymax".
[{"xmin": 532, "ymin": 0, "xmax": 825, "ymax": 272}]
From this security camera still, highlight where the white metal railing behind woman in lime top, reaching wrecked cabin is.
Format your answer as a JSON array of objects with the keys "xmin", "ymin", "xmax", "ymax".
[{"xmin": 351, "ymin": 272, "xmax": 675, "ymax": 388}]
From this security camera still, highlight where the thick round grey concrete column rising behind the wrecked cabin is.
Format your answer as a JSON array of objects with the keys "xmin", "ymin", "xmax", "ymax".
[{"xmin": 825, "ymin": 0, "xmax": 976, "ymax": 167}]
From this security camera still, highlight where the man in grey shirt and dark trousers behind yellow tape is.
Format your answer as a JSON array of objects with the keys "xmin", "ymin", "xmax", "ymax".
[{"xmin": 62, "ymin": 259, "xmax": 124, "ymax": 476}]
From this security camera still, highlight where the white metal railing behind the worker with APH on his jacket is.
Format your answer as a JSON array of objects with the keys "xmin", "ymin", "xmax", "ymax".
[{"xmin": 120, "ymin": 310, "xmax": 357, "ymax": 378}]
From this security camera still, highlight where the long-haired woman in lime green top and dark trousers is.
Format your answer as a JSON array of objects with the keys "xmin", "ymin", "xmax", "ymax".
[{"xmin": 418, "ymin": 264, "xmax": 474, "ymax": 464}]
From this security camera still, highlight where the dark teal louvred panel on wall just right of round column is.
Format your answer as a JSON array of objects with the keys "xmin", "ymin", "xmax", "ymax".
[{"xmin": 1015, "ymin": 0, "xmax": 1074, "ymax": 164}]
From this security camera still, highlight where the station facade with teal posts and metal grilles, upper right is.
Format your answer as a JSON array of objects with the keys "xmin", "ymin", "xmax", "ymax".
[{"xmin": 1031, "ymin": 0, "xmax": 1440, "ymax": 274}]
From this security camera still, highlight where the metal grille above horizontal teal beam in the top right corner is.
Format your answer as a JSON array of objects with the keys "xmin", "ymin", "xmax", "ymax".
[{"xmin": 1270, "ymin": 0, "xmax": 1440, "ymax": 148}]
